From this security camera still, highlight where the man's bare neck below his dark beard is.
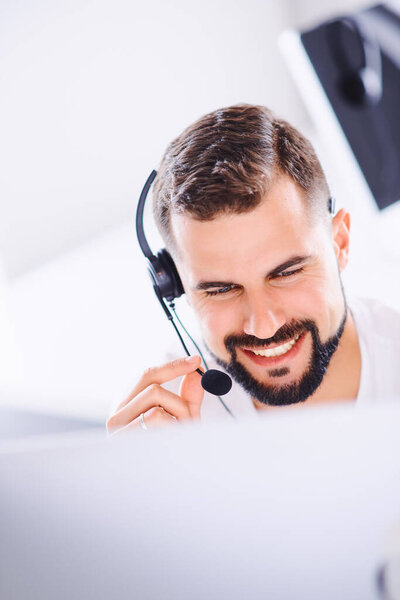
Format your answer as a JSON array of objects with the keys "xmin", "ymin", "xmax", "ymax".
[{"xmin": 253, "ymin": 309, "xmax": 361, "ymax": 410}]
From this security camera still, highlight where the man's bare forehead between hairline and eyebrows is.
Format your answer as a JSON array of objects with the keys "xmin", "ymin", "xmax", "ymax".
[{"xmin": 171, "ymin": 177, "xmax": 324, "ymax": 277}]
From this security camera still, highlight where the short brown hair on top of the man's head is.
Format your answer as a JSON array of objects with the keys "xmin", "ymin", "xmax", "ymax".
[{"xmin": 153, "ymin": 104, "xmax": 329, "ymax": 246}]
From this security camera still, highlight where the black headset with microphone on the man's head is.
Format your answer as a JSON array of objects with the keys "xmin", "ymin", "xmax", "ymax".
[{"xmin": 136, "ymin": 170, "xmax": 335, "ymax": 416}]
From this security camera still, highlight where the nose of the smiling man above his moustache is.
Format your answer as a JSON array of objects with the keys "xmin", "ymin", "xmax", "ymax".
[{"xmin": 243, "ymin": 293, "xmax": 286, "ymax": 339}]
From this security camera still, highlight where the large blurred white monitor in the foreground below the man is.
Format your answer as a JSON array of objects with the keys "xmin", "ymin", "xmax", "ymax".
[{"xmin": 0, "ymin": 401, "xmax": 400, "ymax": 600}]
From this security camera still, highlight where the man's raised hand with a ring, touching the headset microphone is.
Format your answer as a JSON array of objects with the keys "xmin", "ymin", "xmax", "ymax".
[{"xmin": 107, "ymin": 356, "xmax": 204, "ymax": 434}]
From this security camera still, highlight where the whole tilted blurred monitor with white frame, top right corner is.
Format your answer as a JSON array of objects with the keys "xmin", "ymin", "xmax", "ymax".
[{"xmin": 281, "ymin": 3, "xmax": 400, "ymax": 210}]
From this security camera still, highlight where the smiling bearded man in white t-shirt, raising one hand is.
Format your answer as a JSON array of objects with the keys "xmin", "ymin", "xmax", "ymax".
[{"xmin": 107, "ymin": 105, "xmax": 400, "ymax": 430}]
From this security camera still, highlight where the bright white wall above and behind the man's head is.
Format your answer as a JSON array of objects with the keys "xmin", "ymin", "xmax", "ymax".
[{"xmin": 0, "ymin": 0, "xmax": 304, "ymax": 277}]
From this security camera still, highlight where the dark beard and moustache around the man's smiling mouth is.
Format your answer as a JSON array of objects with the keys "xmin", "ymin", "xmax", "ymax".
[{"xmin": 211, "ymin": 302, "xmax": 347, "ymax": 406}]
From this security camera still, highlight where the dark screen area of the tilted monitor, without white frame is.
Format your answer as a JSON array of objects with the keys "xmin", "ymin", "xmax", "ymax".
[{"xmin": 301, "ymin": 5, "xmax": 400, "ymax": 209}]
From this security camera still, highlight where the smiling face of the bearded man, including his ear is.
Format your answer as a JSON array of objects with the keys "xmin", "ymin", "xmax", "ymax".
[{"xmin": 172, "ymin": 176, "xmax": 348, "ymax": 404}]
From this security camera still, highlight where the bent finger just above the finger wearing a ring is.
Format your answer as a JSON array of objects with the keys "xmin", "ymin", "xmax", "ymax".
[{"xmin": 107, "ymin": 383, "xmax": 190, "ymax": 430}]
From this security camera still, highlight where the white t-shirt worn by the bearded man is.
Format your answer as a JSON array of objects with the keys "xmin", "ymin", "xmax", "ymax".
[{"xmin": 167, "ymin": 298, "xmax": 400, "ymax": 421}]
